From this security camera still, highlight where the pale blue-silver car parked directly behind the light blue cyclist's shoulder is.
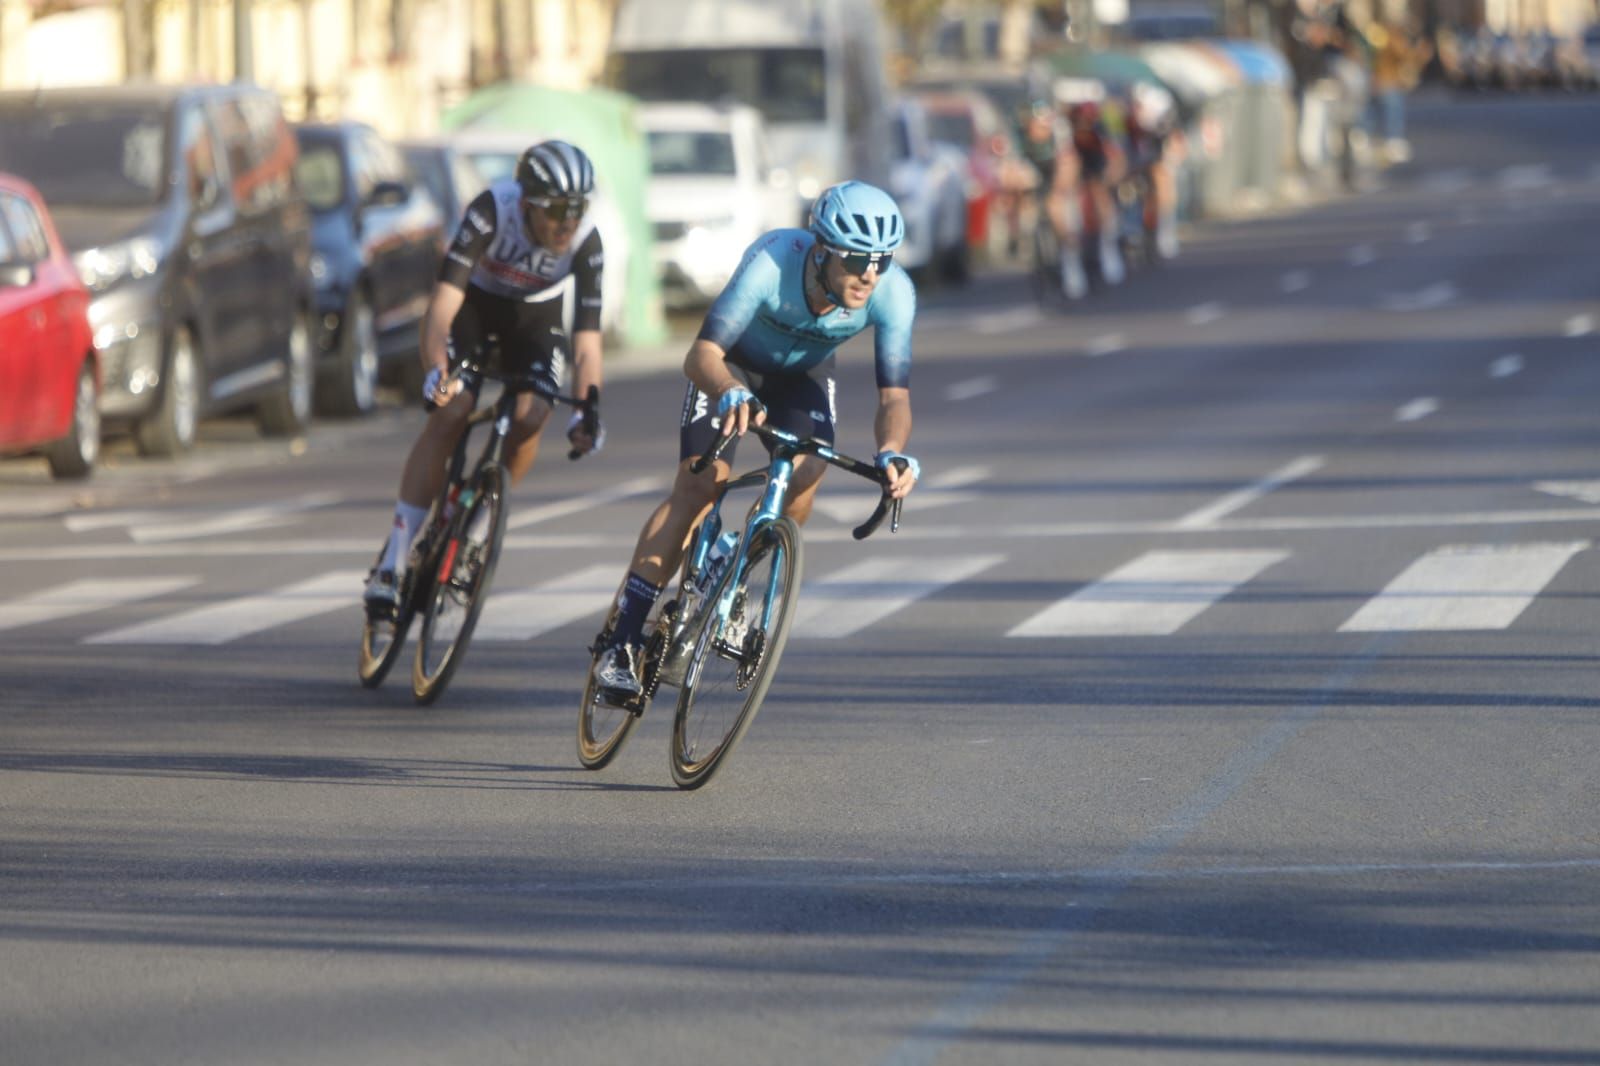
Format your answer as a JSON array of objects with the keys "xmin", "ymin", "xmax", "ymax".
[{"xmin": 890, "ymin": 98, "xmax": 970, "ymax": 282}]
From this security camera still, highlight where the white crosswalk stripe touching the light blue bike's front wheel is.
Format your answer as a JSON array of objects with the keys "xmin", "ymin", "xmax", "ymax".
[{"xmin": 792, "ymin": 555, "xmax": 1005, "ymax": 639}]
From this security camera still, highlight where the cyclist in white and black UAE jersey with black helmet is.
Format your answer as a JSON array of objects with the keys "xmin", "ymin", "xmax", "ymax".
[{"xmin": 366, "ymin": 141, "xmax": 605, "ymax": 616}]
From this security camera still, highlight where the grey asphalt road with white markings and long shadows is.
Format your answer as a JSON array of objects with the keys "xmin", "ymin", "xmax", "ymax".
[{"xmin": 0, "ymin": 98, "xmax": 1600, "ymax": 1066}]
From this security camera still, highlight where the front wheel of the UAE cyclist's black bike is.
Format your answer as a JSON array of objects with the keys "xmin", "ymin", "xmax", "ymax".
[{"xmin": 411, "ymin": 466, "xmax": 506, "ymax": 704}]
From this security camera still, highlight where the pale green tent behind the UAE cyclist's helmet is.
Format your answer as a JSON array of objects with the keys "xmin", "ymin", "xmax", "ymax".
[{"xmin": 440, "ymin": 82, "xmax": 667, "ymax": 346}]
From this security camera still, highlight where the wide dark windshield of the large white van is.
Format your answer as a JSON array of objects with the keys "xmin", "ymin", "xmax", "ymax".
[{"xmin": 606, "ymin": 48, "xmax": 827, "ymax": 123}]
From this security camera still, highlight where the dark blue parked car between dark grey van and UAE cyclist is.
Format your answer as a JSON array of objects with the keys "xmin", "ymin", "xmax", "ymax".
[{"xmin": 294, "ymin": 122, "xmax": 445, "ymax": 415}]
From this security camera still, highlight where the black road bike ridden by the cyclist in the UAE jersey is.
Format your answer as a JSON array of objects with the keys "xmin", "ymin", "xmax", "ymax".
[{"xmin": 360, "ymin": 349, "xmax": 600, "ymax": 704}]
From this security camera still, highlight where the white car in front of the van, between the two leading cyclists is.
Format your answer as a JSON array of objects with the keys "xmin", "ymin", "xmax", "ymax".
[{"xmin": 638, "ymin": 104, "xmax": 798, "ymax": 307}]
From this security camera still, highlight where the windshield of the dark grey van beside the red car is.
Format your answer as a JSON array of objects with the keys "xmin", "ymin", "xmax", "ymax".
[{"xmin": 0, "ymin": 104, "xmax": 166, "ymax": 208}]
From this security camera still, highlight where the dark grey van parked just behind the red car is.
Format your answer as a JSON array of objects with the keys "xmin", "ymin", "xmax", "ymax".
[{"xmin": 0, "ymin": 85, "xmax": 314, "ymax": 455}]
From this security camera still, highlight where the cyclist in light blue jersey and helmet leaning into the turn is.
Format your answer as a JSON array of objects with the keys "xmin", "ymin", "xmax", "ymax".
[{"xmin": 595, "ymin": 181, "xmax": 920, "ymax": 699}]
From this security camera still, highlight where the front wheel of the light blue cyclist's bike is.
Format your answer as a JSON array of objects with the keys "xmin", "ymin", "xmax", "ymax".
[{"xmin": 670, "ymin": 517, "xmax": 803, "ymax": 789}]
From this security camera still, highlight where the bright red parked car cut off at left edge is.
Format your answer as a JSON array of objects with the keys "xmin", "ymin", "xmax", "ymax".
[{"xmin": 0, "ymin": 174, "xmax": 99, "ymax": 477}]
